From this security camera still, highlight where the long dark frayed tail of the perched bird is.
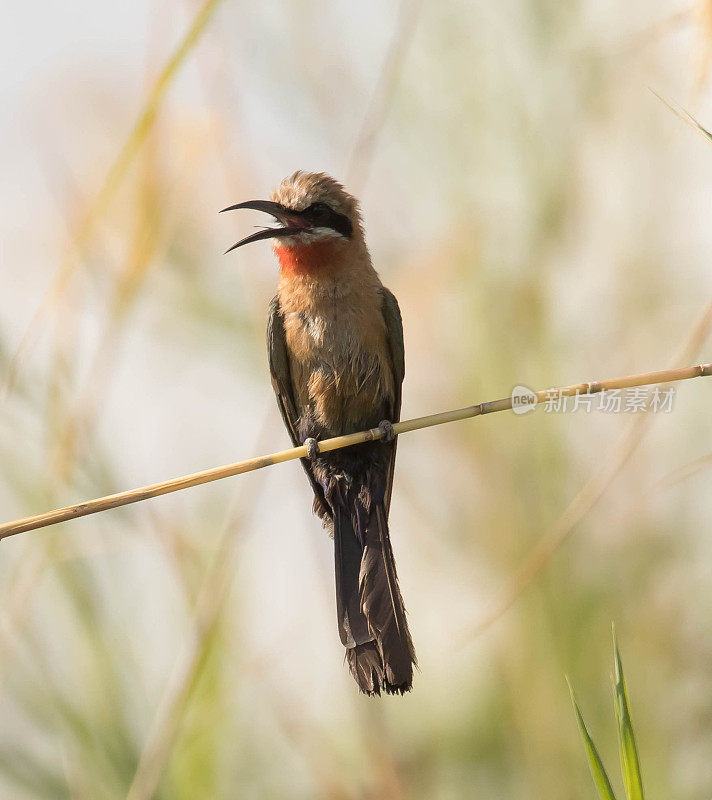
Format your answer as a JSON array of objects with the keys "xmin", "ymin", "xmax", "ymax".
[{"xmin": 334, "ymin": 505, "xmax": 415, "ymax": 695}]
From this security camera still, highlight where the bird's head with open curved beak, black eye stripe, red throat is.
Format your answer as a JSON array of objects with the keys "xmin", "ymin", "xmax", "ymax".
[{"xmin": 223, "ymin": 171, "xmax": 363, "ymax": 267}]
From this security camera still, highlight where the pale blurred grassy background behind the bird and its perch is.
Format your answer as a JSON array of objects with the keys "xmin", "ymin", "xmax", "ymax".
[{"xmin": 0, "ymin": 0, "xmax": 712, "ymax": 800}]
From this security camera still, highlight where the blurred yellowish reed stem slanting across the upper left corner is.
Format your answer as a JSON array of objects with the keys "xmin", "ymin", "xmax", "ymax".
[{"xmin": 3, "ymin": 0, "xmax": 222, "ymax": 396}]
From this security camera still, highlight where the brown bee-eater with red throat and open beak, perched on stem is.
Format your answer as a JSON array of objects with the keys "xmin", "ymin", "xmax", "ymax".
[{"xmin": 224, "ymin": 172, "xmax": 416, "ymax": 695}]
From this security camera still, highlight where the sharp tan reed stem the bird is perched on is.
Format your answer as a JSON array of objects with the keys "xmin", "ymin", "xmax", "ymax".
[{"xmin": 0, "ymin": 364, "xmax": 712, "ymax": 539}]
